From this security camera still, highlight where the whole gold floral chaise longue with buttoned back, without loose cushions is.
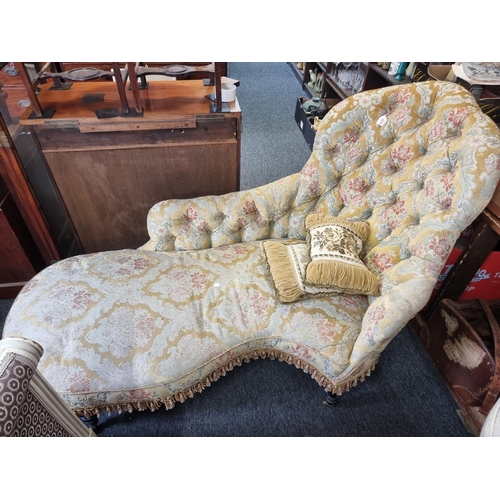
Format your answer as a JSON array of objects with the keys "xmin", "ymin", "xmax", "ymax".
[{"xmin": 0, "ymin": 81, "xmax": 500, "ymax": 416}]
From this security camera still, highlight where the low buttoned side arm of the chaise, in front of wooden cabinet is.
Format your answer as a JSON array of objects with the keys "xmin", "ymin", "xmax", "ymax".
[{"xmin": 140, "ymin": 173, "xmax": 317, "ymax": 252}]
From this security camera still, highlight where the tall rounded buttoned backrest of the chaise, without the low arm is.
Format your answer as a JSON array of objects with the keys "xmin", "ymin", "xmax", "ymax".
[{"xmin": 304, "ymin": 81, "xmax": 500, "ymax": 288}]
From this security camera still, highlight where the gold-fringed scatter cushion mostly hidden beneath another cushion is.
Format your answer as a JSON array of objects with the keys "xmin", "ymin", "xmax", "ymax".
[{"xmin": 263, "ymin": 241, "xmax": 342, "ymax": 303}]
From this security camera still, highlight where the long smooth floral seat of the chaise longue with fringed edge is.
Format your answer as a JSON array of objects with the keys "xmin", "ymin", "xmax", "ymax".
[{"xmin": 4, "ymin": 242, "xmax": 368, "ymax": 414}]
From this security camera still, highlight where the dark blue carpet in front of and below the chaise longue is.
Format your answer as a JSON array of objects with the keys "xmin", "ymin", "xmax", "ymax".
[{"xmin": 94, "ymin": 327, "xmax": 472, "ymax": 437}]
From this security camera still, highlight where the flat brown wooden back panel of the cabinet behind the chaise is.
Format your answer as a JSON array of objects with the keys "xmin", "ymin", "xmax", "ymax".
[{"xmin": 45, "ymin": 141, "xmax": 239, "ymax": 253}]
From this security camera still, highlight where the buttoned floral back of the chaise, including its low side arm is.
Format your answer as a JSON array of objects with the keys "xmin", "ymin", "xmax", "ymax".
[{"xmin": 141, "ymin": 81, "xmax": 500, "ymax": 276}]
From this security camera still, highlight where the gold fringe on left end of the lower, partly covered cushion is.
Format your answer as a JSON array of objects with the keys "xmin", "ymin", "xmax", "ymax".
[{"xmin": 263, "ymin": 241, "xmax": 303, "ymax": 303}]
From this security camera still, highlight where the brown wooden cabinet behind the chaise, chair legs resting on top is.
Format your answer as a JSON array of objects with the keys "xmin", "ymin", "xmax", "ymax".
[{"xmin": 19, "ymin": 80, "xmax": 241, "ymax": 253}]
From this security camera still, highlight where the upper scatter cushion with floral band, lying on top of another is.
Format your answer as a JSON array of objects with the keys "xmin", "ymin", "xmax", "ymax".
[{"xmin": 305, "ymin": 214, "xmax": 380, "ymax": 295}]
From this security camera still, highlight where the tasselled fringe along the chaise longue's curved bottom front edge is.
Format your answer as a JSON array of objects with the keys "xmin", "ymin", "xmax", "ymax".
[{"xmin": 73, "ymin": 349, "xmax": 378, "ymax": 418}]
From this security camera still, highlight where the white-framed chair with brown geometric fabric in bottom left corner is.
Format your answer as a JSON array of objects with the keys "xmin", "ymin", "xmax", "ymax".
[{"xmin": 0, "ymin": 338, "xmax": 95, "ymax": 437}]
